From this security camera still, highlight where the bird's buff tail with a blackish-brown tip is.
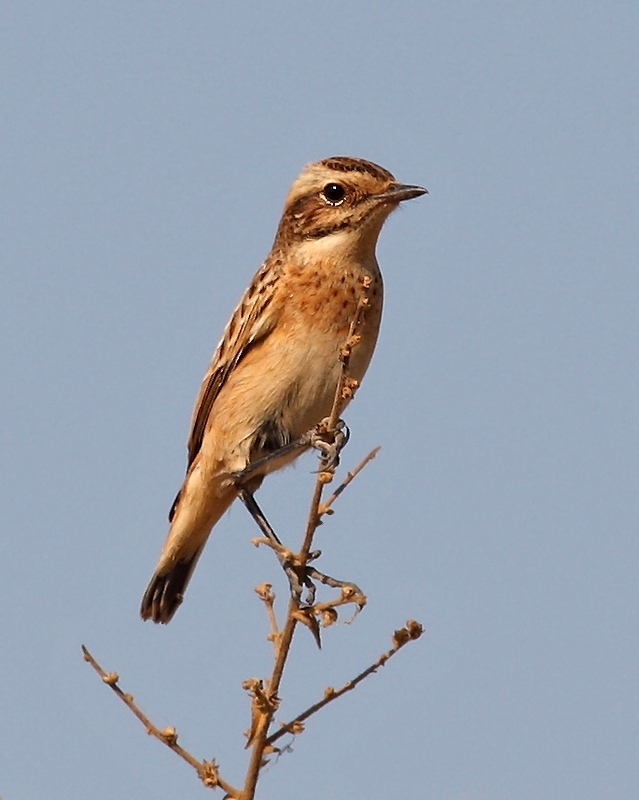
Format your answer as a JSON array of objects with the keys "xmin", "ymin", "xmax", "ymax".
[{"xmin": 140, "ymin": 478, "xmax": 235, "ymax": 625}]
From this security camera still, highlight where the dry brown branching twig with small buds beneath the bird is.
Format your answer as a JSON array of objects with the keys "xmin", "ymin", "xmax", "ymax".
[{"xmin": 82, "ymin": 286, "xmax": 423, "ymax": 800}]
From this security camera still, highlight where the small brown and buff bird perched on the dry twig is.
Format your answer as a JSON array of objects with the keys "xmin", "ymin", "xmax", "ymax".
[{"xmin": 140, "ymin": 156, "xmax": 426, "ymax": 623}]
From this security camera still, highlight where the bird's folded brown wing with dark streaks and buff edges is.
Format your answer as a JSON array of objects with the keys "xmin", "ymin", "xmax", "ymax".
[{"xmin": 187, "ymin": 260, "xmax": 281, "ymax": 469}]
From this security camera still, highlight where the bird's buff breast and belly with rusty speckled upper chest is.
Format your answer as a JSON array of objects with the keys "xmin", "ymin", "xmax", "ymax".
[{"xmin": 204, "ymin": 260, "xmax": 382, "ymax": 471}]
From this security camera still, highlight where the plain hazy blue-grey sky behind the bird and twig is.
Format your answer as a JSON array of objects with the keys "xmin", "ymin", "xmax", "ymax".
[{"xmin": 0, "ymin": 0, "xmax": 639, "ymax": 800}]
